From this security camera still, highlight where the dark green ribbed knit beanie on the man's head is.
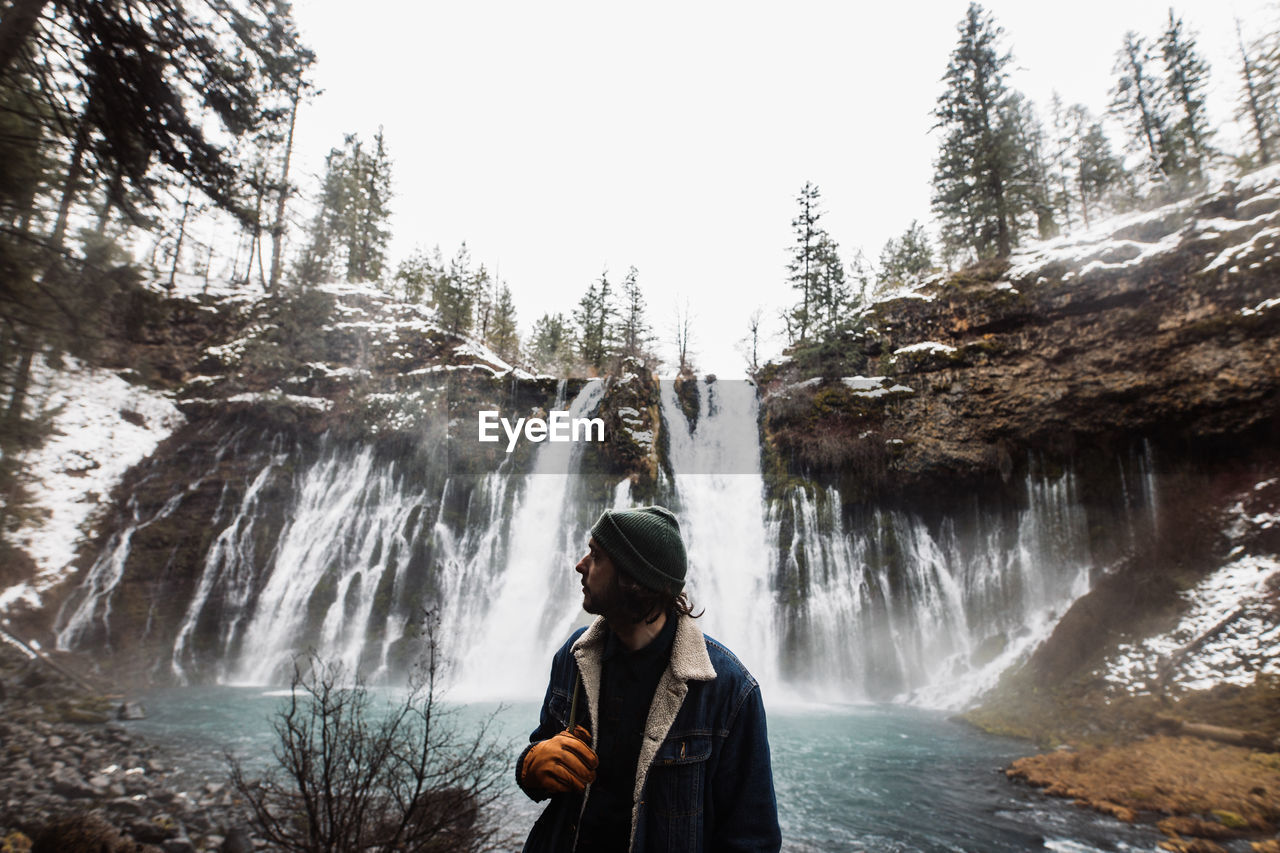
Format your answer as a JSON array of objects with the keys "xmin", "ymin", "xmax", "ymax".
[{"xmin": 591, "ymin": 506, "xmax": 689, "ymax": 596}]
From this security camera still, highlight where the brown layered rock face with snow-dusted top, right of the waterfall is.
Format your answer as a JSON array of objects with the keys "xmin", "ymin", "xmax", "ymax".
[{"xmin": 764, "ymin": 169, "xmax": 1280, "ymax": 491}]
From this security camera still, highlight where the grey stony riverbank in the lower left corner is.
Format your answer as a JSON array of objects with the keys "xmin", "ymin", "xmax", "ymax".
[{"xmin": 0, "ymin": 643, "xmax": 255, "ymax": 853}]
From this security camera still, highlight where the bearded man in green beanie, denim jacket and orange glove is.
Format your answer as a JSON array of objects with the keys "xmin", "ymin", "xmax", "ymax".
[{"xmin": 516, "ymin": 506, "xmax": 782, "ymax": 853}]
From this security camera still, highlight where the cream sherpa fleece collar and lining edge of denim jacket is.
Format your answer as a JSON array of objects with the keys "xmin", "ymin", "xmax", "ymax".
[{"xmin": 572, "ymin": 616, "xmax": 716, "ymax": 841}]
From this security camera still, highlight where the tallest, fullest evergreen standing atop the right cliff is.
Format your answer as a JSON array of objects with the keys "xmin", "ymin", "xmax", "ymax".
[{"xmin": 933, "ymin": 3, "xmax": 1030, "ymax": 257}]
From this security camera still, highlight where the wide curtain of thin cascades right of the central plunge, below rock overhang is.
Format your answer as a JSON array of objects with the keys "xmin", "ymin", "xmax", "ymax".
[{"xmin": 769, "ymin": 473, "xmax": 1111, "ymax": 707}]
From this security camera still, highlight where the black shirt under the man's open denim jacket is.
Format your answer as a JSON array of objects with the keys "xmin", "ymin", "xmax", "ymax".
[{"xmin": 577, "ymin": 615, "xmax": 676, "ymax": 853}]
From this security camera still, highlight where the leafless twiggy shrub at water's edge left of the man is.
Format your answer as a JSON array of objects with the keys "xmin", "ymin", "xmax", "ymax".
[{"xmin": 228, "ymin": 616, "xmax": 511, "ymax": 853}]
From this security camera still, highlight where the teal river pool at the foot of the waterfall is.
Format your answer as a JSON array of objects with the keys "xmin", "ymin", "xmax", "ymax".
[{"xmin": 128, "ymin": 686, "xmax": 1161, "ymax": 853}]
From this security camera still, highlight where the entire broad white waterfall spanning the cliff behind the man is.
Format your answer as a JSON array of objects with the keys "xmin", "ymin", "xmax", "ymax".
[{"xmin": 59, "ymin": 368, "xmax": 1155, "ymax": 707}]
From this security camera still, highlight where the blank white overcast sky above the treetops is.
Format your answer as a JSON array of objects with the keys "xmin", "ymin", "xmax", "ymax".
[{"xmin": 285, "ymin": 0, "xmax": 1280, "ymax": 375}]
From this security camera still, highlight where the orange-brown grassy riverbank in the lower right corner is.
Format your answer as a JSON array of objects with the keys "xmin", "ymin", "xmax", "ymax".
[{"xmin": 965, "ymin": 678, "xmax": 1280, "ymax": 853}]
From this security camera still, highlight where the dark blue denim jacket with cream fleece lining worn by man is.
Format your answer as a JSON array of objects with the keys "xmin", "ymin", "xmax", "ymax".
[{"xmin": 517, "ymin": 616, "xmax": 782, "ymax": 853}]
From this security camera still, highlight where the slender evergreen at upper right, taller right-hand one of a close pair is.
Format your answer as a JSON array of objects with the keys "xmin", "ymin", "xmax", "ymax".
[{"xmin": 1160, "ymin": 9, "xmax": 1212, "ymax": 184}]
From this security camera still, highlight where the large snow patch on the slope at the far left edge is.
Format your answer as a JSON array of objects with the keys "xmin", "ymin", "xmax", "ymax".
[{"xmin": 0, "ymin": 357, "xmax": 186, "ymax": 611}]
